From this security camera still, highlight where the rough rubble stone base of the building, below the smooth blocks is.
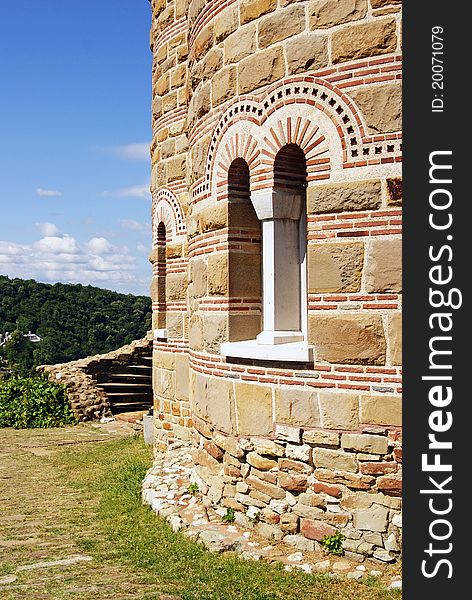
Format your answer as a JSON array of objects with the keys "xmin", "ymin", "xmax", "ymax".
[{"xmin": 193, "ymin": 417, "xmax": 401, "ymax": 563}]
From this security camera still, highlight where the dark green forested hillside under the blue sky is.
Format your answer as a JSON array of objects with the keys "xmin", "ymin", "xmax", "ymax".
[{"xmin": 0, "ymin": 275, "xmax": 151, "ymax": 370}]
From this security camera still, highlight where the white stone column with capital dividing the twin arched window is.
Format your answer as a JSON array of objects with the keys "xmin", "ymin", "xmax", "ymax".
[{"xmin": 251, "ymin": 189, "xmax": 304, "ymax": 345}]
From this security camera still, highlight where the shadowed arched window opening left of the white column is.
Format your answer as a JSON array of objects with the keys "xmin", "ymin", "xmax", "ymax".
[{"xmin": 228, "ymin": 158, "xmax": 262, "ymax": 342}]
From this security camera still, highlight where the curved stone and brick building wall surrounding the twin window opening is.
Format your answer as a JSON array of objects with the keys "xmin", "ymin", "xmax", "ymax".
[{"xmin": 150, "ymin": 0, "xmax": 402, "ymax": 561}]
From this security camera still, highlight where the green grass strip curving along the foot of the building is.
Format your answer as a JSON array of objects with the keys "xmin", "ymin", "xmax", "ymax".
[{"xmin": 53, "ymin": 438, "xmax": 401, "ymax": 600}]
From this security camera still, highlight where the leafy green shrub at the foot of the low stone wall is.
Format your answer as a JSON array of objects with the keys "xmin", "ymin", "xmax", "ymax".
[{"xmin": 0, "ymin": 376, "xmax": 77, "ymax": 429}]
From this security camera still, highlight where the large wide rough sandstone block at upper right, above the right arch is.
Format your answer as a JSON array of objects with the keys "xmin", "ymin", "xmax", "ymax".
[{"xmin": 332, "ymin": 18, "xmax": 397, "ymax": 63}]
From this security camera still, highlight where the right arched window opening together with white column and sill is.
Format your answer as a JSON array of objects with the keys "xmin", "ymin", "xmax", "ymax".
[{"xmin": 222, "ymin": 144, "xmax": 313, "ymax": 362}]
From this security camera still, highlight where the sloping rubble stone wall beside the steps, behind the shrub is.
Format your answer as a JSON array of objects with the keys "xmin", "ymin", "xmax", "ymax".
[{"xmin": 38, "ymin": 338, "xmax": 152, "ymax": 421}]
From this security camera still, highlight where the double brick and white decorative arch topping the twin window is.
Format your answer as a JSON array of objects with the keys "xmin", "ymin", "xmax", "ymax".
[{"xmin": 200, "ymin": 76, "xmax": 402, "ymax": 199}]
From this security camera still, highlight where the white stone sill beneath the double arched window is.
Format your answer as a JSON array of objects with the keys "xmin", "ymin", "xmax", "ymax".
[{"xmin": 220, "ymin": 340, "xmax": 314, "ymax": 362}]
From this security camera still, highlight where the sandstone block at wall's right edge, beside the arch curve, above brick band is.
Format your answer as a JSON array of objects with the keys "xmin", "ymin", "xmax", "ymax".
[{"xmin": 351, "ymin": 83, "xmax": 402, "ymax": 134}]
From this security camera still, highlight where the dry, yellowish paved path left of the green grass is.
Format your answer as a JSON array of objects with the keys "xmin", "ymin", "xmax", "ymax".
[{"xmin": 0, "ymin": 423, "xmax": 166, "ymax": 600}]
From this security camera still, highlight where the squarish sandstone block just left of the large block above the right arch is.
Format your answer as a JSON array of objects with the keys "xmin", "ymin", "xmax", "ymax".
[{"xmin": 285, "ymin": 33, "xmax": 329, "ymax": 75}]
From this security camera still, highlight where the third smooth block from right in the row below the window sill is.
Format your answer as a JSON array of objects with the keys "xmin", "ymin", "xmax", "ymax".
[{"xmin": 275, "ymin": 387, "xmax": 320, "ymax": 427}]
